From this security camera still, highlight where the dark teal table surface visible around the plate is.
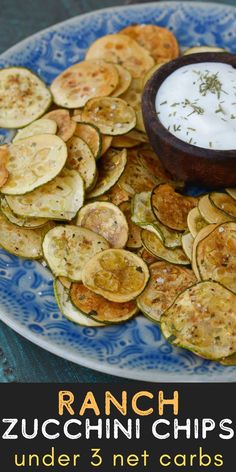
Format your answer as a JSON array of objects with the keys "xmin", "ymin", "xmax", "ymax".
[{"xmin": 0, "ymin": 0, "xmax": 236, "ymax": 383}]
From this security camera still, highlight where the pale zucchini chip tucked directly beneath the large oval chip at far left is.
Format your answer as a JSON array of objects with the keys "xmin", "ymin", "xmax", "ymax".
[{"xmin": 6, "ymin": 169, "xmax": 84, "ymax": 220}]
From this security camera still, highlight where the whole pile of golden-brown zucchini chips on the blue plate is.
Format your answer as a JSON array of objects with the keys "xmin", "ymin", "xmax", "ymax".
[{"xmin": 0, "ymin": 25, "xmax": 236, "ymax": 364}]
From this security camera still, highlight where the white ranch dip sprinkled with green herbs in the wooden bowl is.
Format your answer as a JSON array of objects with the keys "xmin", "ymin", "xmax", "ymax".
[{"xmin": 156, "ymin": 62, "xmax": 236, "ymax": 150}]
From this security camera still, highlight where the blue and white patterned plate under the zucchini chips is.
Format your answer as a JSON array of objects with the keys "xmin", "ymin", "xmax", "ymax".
[{"xmin": 0, "ymin": 2, "xmax": 236, "ymax": 382}]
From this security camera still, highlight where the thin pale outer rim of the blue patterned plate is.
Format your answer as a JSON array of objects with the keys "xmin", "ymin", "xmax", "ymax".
[{"xmin": 0, "ymin": 1, "xmax": 236, "ymax": 383}]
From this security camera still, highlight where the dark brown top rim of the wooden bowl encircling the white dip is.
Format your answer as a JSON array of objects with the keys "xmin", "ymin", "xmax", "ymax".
[{"xmin": 142, "ymin": 52, "xmax": 236, "ymax": 162}]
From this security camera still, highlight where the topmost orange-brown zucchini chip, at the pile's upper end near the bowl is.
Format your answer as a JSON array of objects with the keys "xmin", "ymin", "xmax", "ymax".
[{"xmin": 121, "ymin": 24, "xmax": 179, "ymax": 63}]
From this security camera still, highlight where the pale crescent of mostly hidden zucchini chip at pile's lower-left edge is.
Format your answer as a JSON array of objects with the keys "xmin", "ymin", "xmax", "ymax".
[{"xmin": 53, "ymin": 278, "xmax": 103, "ymax": 328}]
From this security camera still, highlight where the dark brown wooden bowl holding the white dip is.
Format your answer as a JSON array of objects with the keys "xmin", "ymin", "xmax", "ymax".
[{"xmin": 142, "ymin": 52, "xmax": 236, "ymax": 188}]
